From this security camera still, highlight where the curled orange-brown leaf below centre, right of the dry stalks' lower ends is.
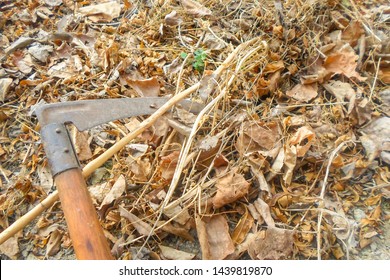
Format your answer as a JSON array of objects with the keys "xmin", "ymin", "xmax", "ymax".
[{"xmin": 212, "ymin": 170, "xmax": 250, "ymax": 209}]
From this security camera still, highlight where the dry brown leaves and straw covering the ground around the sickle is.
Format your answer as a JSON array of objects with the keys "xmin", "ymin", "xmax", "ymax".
[{"xmin": 0, "ymin": 0, "xmax": 390, "ymax": 259}]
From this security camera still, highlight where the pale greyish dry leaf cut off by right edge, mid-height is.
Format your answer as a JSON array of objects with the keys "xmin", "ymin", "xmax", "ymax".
[{"xmin": 360, "ymin": 117, "xmax": 390, "ymax": 161}]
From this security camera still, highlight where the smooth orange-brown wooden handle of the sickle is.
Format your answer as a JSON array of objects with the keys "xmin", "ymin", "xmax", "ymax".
[{"xmin": 54, "ymin": 168, "xmax": 113, "ymax": 260}]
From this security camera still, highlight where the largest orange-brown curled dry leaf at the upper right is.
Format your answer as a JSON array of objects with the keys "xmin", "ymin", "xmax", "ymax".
[{"xmin": 323, "ymin": 44, "xmax": 366, "ymax": 81}]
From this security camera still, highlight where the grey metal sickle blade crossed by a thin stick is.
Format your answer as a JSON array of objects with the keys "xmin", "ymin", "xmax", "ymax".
[{"xmin": 35, "ymin": 97, "xmax": 204, "ymax": 131}]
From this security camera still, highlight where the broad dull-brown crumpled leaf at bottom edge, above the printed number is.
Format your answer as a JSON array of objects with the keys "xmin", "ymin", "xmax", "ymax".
[{"xmin": 248, "ymin": 227, "xmax": 294, "ymax": 260}]
